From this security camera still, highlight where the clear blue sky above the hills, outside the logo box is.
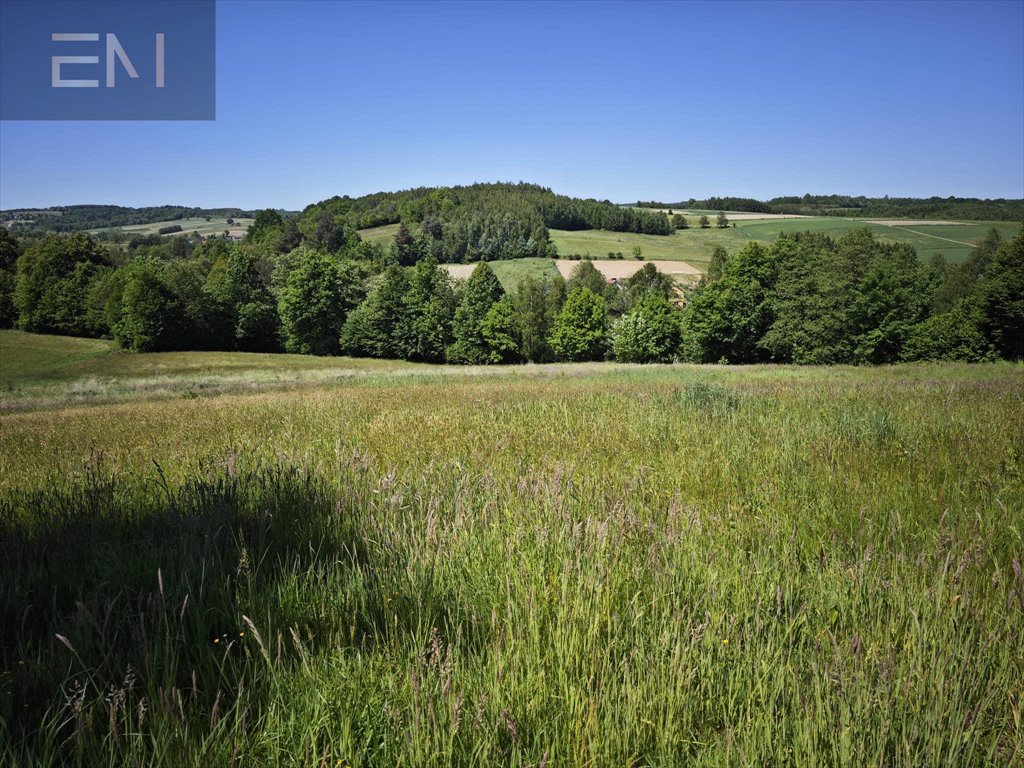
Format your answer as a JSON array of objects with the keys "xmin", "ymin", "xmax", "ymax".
[{"xmin": 0, "ymin": 0, "xmax": 1024, "ymax": 209}]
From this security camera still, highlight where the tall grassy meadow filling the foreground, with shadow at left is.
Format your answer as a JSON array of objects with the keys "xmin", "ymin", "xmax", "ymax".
[{"xmin": 0, "ymin": 333, "xmax": 1024, "ymax": 767}]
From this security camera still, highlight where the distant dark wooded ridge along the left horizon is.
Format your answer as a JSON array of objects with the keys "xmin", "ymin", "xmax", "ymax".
[{"xmin": 0, "ymin": 205, "xmax": 253, "ymax": 234}]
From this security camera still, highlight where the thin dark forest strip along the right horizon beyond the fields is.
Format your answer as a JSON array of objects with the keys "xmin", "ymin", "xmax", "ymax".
[{"xmin": 637, "ymin": 195, "xmax": 1024, "ymax": 221}]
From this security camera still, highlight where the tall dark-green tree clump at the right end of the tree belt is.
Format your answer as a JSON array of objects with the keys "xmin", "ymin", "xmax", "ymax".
[{"xmin": 682, "ymin": 229, "xmax": 1024, "ymax": 365}]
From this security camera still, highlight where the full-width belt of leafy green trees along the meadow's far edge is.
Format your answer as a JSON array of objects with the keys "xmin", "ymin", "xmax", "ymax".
[{"xmin": 0, "ymin": 210, "xmax": 1024, "ymax": 365}]
